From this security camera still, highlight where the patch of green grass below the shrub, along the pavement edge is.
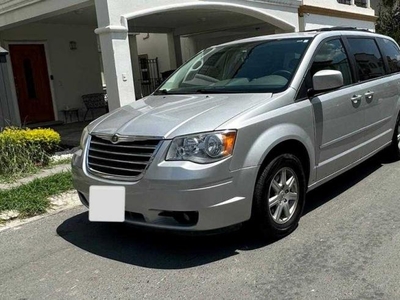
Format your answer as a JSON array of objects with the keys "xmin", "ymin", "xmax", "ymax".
[{"xmin": 0, "ymin": 172, "xmax": 73, "ymax": 218}]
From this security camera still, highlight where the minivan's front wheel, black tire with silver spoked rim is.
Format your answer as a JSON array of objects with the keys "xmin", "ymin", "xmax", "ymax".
[{"xmin": 252, "ymin": 154, "xmax": 306, "ymax": 240}]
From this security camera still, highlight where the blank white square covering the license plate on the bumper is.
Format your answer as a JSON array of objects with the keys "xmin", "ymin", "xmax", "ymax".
[{"xmin": 89, "ymin": 186, "xmax": 125, "ymax": 222}]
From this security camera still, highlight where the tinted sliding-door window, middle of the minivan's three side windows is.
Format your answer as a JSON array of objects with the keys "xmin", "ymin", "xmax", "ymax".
[{"xmin": 348, "ymin": 38, "xmax": 385, "ymax": 81}]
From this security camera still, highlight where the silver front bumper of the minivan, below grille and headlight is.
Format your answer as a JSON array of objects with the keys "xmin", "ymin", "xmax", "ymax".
[{"xmin": 72, "ymin": 143, "xmax": 257, "ymax": 231}]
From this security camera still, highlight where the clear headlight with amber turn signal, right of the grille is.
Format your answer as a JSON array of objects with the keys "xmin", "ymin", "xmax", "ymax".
[{"xmin": 166, "ymin": 130, "xmax": 236, "ymax": 164}]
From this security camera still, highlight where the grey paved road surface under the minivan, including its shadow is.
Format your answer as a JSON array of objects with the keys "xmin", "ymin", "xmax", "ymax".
[{"xmin": 0, "ymin": 153, "xmax": 400, "ymax": 300}]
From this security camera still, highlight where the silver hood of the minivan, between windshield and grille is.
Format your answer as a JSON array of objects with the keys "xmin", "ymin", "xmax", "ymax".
[{"xmin": 89, "ymin": 94, "xmax": 272, "ymax": 138}]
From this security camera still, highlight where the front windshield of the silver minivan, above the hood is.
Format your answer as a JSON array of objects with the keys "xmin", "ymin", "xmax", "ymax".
[{"xmin": 154, "ymin": 38, "xmax": 310, "ymax": 95}]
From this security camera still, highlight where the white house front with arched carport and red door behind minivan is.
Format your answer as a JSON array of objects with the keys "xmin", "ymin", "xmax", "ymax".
[{"xmin": 0, "ymin": 0, "xmax": 376, "ymax": 124}]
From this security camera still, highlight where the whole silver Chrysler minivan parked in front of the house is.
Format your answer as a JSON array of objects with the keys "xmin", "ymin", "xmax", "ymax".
[{"xmin": 72, "ymin": 28, "xmax": 400, "ymax": 238}]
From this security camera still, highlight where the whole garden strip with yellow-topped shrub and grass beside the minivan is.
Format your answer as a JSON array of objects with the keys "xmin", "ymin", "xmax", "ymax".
[{"xmin": 0, "ymin": 127, "xmax": 77, "ymax": 225}]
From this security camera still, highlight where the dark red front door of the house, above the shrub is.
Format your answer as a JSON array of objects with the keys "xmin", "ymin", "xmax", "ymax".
[{"xmin": 9, "ymin": 45, "xmax": 54, "ymax": 124}]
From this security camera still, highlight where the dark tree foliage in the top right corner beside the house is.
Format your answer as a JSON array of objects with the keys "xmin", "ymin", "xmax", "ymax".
[{"xmin": 376, "ymin": 0, "xmax": 400, "ymax": 42}]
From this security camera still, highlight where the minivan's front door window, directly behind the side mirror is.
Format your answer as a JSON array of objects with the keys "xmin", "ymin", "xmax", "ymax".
[{"xmin": 311, "ymin": 39, "xmax": 353, "ymax": 85}]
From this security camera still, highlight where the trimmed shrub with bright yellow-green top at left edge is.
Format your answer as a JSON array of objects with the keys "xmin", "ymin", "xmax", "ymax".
[{"xmin": 0, "ymin": 127, "xmax": 60, "ymax": 177}]
